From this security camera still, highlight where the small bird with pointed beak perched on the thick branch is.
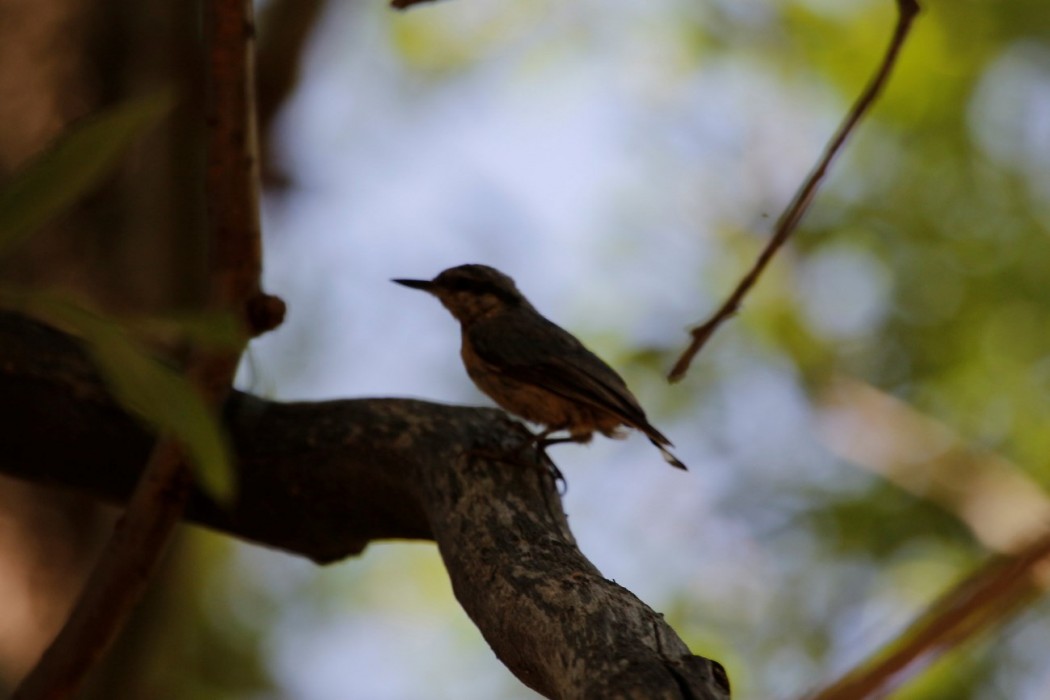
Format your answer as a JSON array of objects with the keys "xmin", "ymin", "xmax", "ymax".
[{"xmin": 393, "ymin": 264, "xmax": 686, "ymax": 469}]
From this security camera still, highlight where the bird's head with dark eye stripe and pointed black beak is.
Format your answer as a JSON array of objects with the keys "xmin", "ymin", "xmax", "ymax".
[{"xmin": 393, "ymin": 264, "xmax": 528, "ymax": 323}]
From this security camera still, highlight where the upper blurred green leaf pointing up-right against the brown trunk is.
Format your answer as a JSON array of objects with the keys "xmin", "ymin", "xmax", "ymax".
[{"xmin": 0, "ymin": 90, "xmax": 174, "ymax": 256}]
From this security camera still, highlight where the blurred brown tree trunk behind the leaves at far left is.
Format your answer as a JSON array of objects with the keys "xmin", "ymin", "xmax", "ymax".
[{"xmin": 0, "ymin": 0, "xmax": 204, "ymax": 697}]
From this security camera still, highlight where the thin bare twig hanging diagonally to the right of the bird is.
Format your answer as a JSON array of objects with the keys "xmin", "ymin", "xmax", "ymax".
[{"xmin": 668, "ymin": 0, "xmax": 919, "ymax": 382}]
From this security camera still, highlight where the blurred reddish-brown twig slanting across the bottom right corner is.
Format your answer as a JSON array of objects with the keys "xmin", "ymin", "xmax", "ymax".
[{"xmin": 806, "ymin": 536, "xmax": 1050, "ymax": 700}]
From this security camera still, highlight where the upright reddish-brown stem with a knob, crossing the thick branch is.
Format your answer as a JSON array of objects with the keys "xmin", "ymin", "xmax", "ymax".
[{"xmin": 13, "ymin": 0, "xmax": 266, "ymax": 700}]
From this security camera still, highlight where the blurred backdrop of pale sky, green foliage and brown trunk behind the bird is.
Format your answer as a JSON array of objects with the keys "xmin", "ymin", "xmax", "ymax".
[{"xmin": 0, "ymin": 0, "xmax": 1050, "ymax": 700}]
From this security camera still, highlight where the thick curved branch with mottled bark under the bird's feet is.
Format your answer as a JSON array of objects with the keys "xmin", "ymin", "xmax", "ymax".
[{"xmin": 0, "ymin": 314, "xmax": 729, "ymax": 699}]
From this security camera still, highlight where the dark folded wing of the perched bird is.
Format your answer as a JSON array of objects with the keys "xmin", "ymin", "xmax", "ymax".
[{"xmin": 468, "ymin": 317, "xmax": 671, "ymax": 445}]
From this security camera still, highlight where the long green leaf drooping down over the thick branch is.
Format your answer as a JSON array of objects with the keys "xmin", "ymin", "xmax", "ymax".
[{"xmin": 0, "ymin": 289, "xmax": 235, "ymax": 502}]
